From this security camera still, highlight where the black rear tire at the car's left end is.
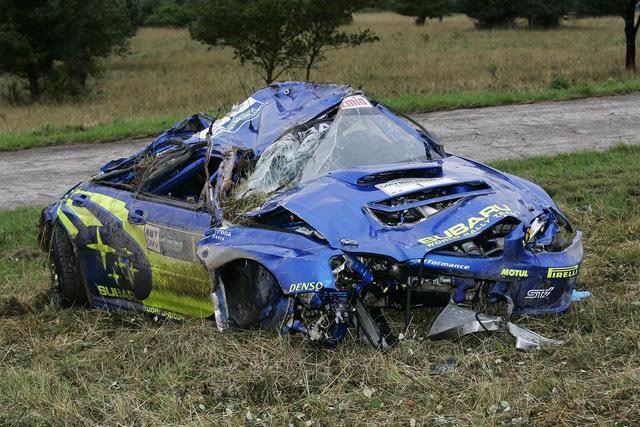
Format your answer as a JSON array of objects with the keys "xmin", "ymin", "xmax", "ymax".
[{"xmin": 51, "ymin": 224, "xmax": 89, "ymax": 307}]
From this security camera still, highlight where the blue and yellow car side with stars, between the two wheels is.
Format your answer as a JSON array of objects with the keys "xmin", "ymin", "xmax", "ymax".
[{"xmin": 64, "ymin": 185, "xmax": 213, "ymax": 318}]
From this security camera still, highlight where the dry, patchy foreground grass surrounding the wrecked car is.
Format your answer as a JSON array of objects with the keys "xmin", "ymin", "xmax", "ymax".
[{"xmin": 0, "ymin": 146, "xmax": 640, "ymax": 425}]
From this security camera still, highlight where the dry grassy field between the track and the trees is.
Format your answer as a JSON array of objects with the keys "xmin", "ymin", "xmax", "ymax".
[{"xmin": 0, "ymin": 13, "xmax": 640, "ymax": 150}]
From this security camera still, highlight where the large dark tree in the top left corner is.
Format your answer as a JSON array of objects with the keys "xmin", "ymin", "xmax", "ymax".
[{"xmin": 0, "ymin": 0, "xmax": 134, "ymax": 100}]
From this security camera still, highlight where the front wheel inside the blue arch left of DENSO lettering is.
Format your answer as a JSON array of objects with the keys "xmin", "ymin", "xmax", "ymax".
[{"xmin": 220, "ymin": 260, "xmax": 284, "ymax": 329}]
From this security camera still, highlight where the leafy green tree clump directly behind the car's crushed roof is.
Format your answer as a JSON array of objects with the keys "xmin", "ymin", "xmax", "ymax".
[{"xmin": 189, "ymin": 0, "xmax": 376, "ymax": 84}]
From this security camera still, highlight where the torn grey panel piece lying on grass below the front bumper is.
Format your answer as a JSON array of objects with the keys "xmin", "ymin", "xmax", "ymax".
[{"xmin": 428, "ymin": 303, "xmax": 564, "ymax": 351}]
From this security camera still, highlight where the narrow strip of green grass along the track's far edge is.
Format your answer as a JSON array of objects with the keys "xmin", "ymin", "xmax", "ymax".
[{"xmin": 0, "ymin": 79, "xmax": 640, "ymax": 151}]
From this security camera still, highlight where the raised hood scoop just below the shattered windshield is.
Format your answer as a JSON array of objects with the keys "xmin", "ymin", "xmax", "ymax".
[{"xmin": 327, "ymin": 161, "xmax": 442, "ymax": 185}]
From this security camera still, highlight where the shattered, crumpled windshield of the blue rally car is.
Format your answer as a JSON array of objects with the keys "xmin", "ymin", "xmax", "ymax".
[{"xmin": 247, "ymin": 101, "xmax": 436, "ymax": 194}]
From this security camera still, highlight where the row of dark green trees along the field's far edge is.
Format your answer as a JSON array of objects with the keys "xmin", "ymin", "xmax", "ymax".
[{"xmin": 0, "ymin": 0, "xmax": 640, "ymax": 101}]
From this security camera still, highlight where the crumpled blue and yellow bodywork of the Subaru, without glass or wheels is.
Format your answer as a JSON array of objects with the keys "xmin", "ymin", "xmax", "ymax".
[{"xmin": 43, "ymin": 82, "xmax": 583, "ymax": 334}]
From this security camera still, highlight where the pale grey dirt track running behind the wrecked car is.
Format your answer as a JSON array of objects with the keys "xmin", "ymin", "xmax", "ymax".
[{"xmin": 0, "ymin": 95, "xmax": 640, "ymax": 209}]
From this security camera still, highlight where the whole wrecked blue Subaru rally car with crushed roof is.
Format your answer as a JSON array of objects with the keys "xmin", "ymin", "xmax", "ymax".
[{"xmin": 40, "ymin": 82, "xmax": 582, "ymax": 349}]
